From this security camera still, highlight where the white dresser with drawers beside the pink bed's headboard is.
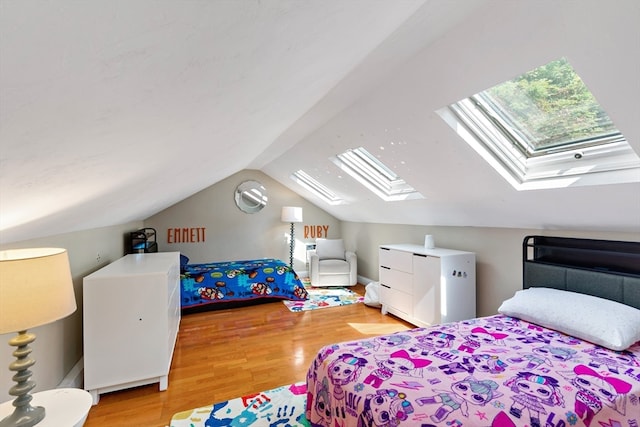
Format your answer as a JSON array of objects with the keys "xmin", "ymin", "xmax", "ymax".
[{"xmin": 379, "ymin": 244, "xmax": 476, "ymax": 326}]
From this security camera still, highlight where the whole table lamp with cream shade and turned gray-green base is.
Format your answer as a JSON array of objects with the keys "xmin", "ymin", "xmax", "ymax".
[{"xmin": 0, "ymin": 248, "xmax": 76, "ymax": 427}]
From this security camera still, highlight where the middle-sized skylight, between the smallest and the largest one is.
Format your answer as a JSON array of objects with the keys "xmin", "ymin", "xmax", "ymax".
[{"xmin": 332, "ymin": 147, "xmax": 423, "ymax": 201}]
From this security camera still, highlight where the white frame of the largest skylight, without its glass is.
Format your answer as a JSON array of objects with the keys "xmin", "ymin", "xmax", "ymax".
[{"xmin": 437, "ymin": 63, "xmax": 640, "ymax": 190}]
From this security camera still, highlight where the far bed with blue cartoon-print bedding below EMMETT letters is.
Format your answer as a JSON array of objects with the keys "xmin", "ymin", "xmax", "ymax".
[{"xmin": 180, "ymin": 258, "xmax": 307, "ymax": 312}]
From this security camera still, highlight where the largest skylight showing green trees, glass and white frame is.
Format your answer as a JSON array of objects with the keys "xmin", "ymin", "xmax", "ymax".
[{"xmin": 438, "ymin": 58, "xmax": 640, "ymax": 190}]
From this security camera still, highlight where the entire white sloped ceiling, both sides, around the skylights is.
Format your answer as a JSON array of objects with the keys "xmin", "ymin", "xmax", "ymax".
[{"xmin": 0, "ymin": 0, "xmax": 640, "ymax": 243}]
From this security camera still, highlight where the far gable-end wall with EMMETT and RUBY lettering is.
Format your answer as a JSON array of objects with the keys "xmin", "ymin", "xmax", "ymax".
[{"xmin": 144, "ymin": 170, "xmax": 341, "ymax": 272}]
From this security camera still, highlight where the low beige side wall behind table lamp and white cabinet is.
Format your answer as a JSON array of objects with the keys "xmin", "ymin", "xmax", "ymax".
[{"xmin": 0, "ymin": 222, "xmax": 142, "ymax": 402}]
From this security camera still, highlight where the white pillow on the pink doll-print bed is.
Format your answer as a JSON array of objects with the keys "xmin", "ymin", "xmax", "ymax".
[{"xmin": 498, "ymin": 288, "xmax": 640, "ymax": 351}]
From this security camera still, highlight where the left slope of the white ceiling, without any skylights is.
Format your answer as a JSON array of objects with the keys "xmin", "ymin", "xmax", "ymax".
[{"xmin": 0, "ymin": 0, "xmax": 424, "ymax": 243}]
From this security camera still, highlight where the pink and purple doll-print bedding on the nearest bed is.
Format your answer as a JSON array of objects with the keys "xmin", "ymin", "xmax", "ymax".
[{"xmin": 306, "ymin": 314, "xmax": 640, "ymax": 427}]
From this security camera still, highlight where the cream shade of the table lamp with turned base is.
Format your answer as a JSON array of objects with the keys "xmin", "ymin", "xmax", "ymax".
[{"xmin": 0, "ymin": 248, "xmax": 76, "ymax": 334}]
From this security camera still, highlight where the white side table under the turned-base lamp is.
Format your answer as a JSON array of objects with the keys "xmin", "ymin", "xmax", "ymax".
[{"xmin": 0, "ymin": 388, "xmax": 93, "ymax": 427}]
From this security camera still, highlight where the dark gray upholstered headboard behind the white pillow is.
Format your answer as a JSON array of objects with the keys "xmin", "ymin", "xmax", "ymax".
[{"xmin": 522, "ymin": 236, "xmax": 640, "ymax": 309}]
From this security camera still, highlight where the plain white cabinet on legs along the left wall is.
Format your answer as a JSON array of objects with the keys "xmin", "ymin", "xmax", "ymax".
[{"xmin": 82, "ymin": 252, "xmax": 180, "ymax": 404}]
